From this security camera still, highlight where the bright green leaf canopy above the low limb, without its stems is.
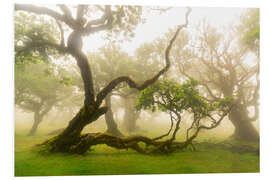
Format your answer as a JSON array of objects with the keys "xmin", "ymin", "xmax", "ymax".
[{"xmin": 137, "ymin": 79, "xmax": 230, "ymax": 116}]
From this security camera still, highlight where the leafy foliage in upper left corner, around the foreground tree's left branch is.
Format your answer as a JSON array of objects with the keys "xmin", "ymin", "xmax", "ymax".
[{"xmin": 14, "ymin": 12, "xmax": 60, "ymax": 63}]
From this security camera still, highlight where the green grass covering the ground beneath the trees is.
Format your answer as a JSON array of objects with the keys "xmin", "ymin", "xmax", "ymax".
[{"xmin": 15, "ymin": 132, "xmax": 259, "ymax": 176}]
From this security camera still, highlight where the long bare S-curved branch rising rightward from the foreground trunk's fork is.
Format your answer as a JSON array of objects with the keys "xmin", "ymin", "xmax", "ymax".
[{"xmin": 96, "ymin": 8, "xmax": 191, "ymax": 105}]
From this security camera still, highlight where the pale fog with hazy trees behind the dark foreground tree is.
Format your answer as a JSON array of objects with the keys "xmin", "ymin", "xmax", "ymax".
[{"xmin": 14, "ymin": 6, "xmax": 259, "ymax": 149}]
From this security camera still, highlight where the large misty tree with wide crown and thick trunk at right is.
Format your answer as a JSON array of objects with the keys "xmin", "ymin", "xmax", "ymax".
[{"xmin": 135, "ymin": 14, "xmax": 259, "ymax": 142}]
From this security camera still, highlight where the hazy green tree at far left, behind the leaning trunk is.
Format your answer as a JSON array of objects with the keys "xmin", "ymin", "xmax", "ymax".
[{"xmin": 15, "ymin": 60, "xmax": 72, "ymax": 135}]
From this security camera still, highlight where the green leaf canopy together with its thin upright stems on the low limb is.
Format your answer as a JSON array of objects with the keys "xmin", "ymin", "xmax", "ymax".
[{"xmin": 137, "ymin": 79, "xmax": 231, "ymax": 145}]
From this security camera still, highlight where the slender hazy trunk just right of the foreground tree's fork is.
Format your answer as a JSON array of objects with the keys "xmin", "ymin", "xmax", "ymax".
[{"xmin": 105, "ymin": 94, "xmax": 123, "ymax": 137}]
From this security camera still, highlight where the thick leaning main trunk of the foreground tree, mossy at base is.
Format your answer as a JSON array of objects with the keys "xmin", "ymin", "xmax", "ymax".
[{"xmin": 42, "ymin": 30, "xmax": 107, "ymax": 152}]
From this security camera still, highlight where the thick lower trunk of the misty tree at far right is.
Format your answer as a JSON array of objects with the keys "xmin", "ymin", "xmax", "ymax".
[{"xmin": 229, "ymin": 106, "xmax": 259, "ymax": 142}]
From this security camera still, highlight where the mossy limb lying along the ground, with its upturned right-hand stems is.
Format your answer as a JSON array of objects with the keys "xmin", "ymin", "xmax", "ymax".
[{"xmin": 38, "ymin": 105, "xmax": 230, "ymax": 154}]
